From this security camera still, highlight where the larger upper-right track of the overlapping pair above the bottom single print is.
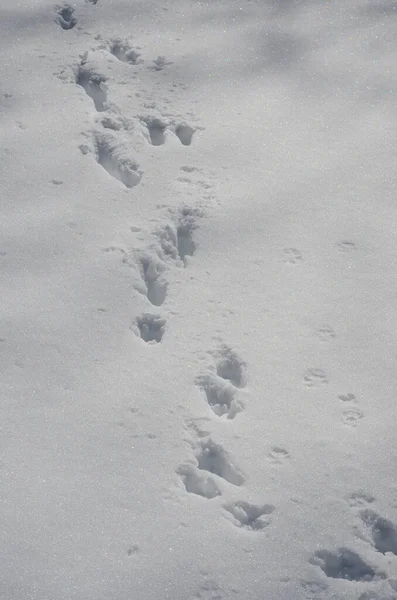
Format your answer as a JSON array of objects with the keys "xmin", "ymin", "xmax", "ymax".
[{"xmin": 196, "ymin": 439, "xmax": 244, "ymax": 486}]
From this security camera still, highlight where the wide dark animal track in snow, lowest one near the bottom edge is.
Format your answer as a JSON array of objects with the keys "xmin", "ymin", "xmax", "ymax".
[{"xmin": 310, "ymin": 548, "xmax": 386, "ymax": 581}]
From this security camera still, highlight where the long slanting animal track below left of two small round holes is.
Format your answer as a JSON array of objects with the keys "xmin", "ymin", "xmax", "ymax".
[{"xmin": 91, "ymin": 133, "xmax": 142, "ymax": 188}]
